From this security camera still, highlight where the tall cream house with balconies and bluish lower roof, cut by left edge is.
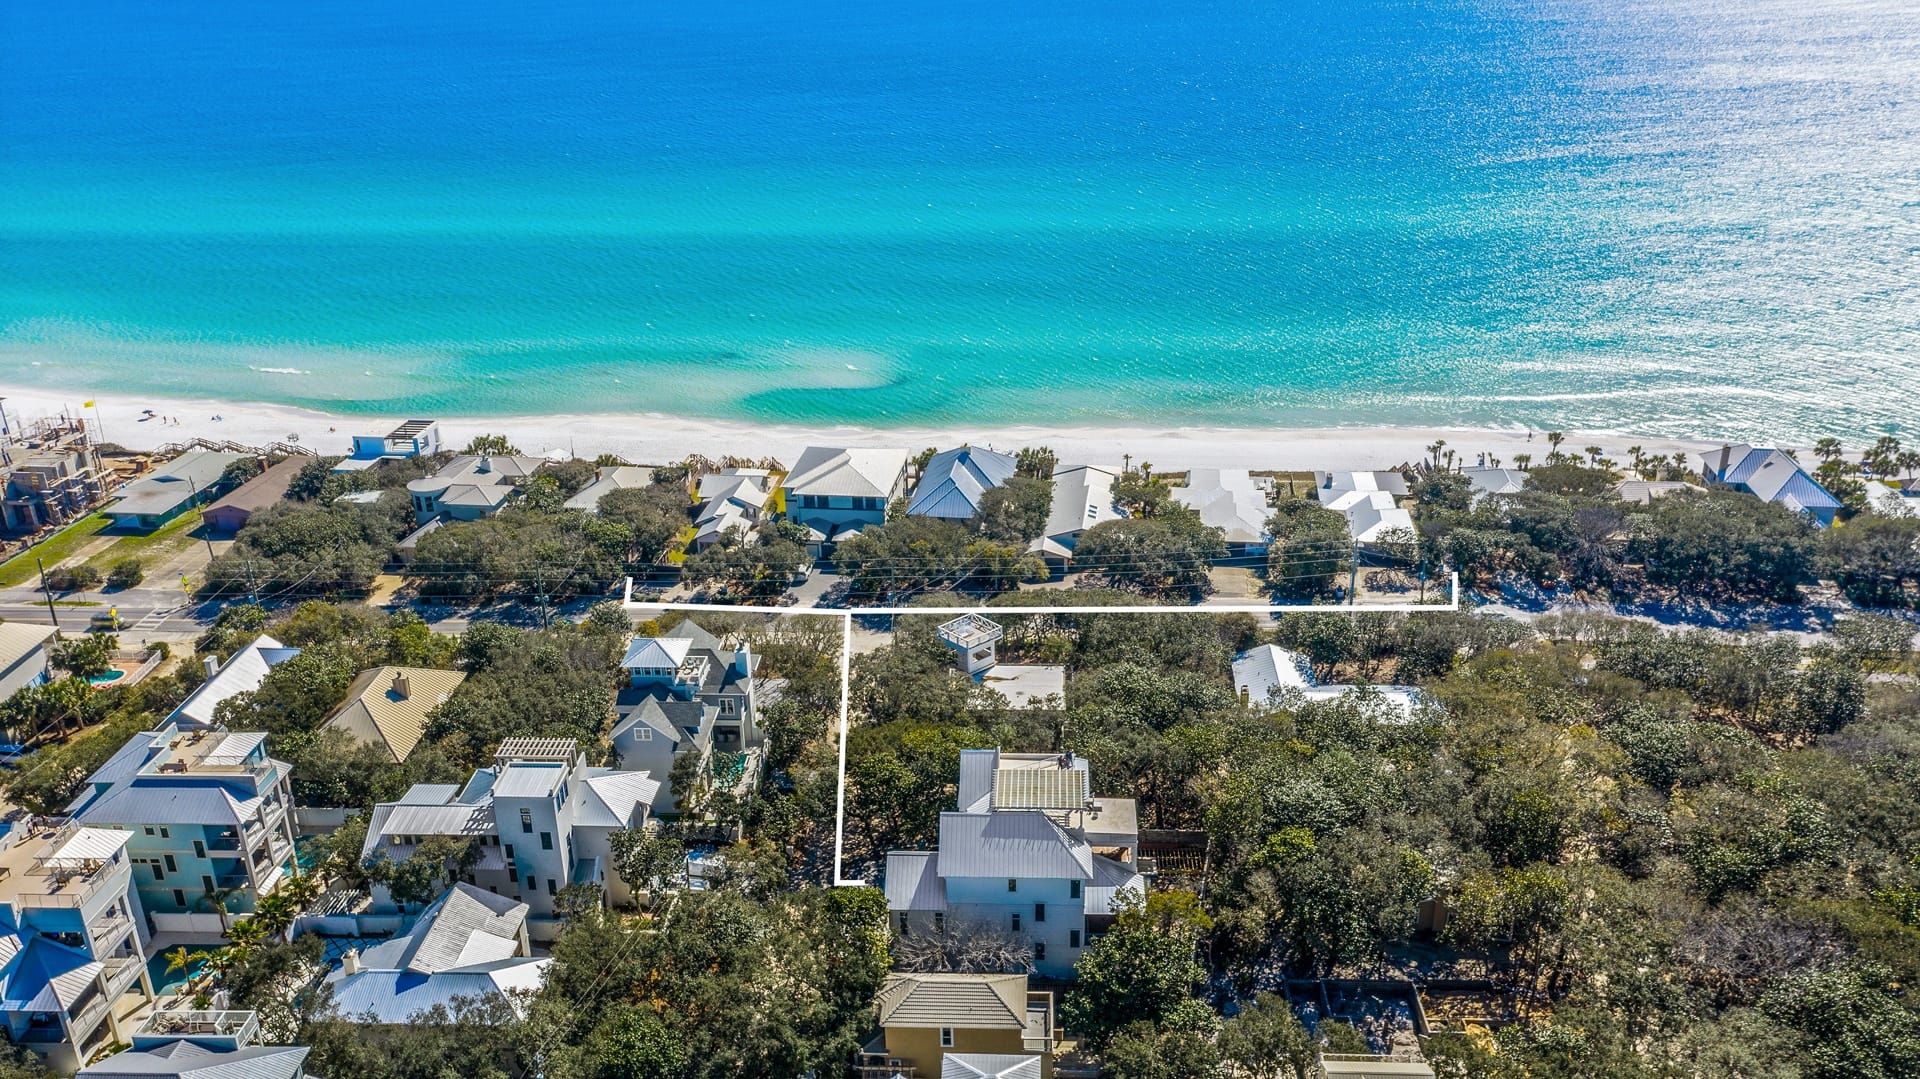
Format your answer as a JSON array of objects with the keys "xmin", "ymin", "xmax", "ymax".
[{"xmin": 0, "ymin": 820, "xmax": 154, "ymax": 1071}]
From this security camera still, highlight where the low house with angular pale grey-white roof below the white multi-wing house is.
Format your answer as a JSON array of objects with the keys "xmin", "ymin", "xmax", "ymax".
[{"xmin": 326, "ymin": 881, "xmax": 553, "ymax": 1025}]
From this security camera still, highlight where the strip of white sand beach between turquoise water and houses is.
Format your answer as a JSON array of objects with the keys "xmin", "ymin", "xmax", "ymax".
[{"xmin": 0, "ymin": 384, "xmax": 1720, "ymax": 470}]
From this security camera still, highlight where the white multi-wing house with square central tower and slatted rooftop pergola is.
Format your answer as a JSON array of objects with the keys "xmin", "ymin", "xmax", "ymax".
[{"xmin": 361, "ymin": 737, "xmax": 660, "ymax": 941}]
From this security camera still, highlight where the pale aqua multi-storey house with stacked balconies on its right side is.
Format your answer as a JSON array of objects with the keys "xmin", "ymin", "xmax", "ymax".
[{"xmin": 67, "ymin": 724, "xmax": 300, "ymax": 931}]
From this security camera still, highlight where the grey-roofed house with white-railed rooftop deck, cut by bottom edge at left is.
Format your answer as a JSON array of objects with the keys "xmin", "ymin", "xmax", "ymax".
[{"xmin": 77, "ymin": 1008, "xmax": 313, "ymax": 1079}]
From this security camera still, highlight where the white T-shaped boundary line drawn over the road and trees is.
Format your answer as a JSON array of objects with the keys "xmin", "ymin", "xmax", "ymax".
[{"xmin": 620, "ymin": 570, "xmax": 1459, "ymax": 887}]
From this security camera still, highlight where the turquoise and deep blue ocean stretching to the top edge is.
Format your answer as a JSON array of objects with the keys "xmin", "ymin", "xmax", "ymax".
[{"xmin": 0, "ymin": 0, "xmax": 1920, "ymax": 442}]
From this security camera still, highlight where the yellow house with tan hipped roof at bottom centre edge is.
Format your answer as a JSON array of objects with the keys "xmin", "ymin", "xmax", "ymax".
[{"xmin": 856, "ymin": 973, "xmax": 1060, "ymax": 1079}]
